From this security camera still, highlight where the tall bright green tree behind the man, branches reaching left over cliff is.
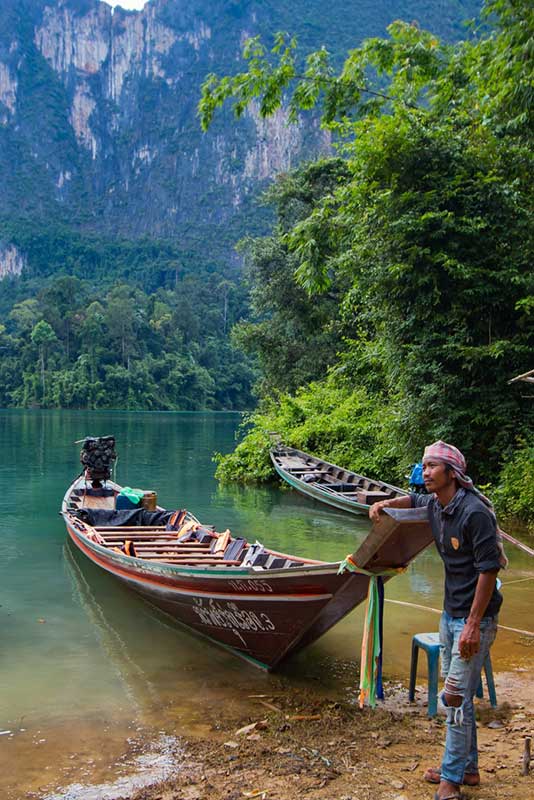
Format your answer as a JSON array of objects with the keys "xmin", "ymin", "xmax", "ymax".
[{"xmin": 199, "ymin": 0, "xmax": 534, "ymax": 479}]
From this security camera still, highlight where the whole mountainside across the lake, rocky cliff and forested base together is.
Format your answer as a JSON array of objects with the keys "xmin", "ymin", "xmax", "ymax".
[{"xmin": 0, "ymin": 0, "xmax": 479, "ymax": 408}]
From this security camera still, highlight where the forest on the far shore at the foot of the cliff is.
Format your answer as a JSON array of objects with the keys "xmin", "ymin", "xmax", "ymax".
[{"xmin": 0, "ymin": 223, "xmax": 254, "ymax": 410}]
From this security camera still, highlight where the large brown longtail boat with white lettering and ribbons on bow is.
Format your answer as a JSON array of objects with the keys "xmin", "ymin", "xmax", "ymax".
[{"xmin": 61, "ymin": 477, "xmax": 432, "ymax": 670}]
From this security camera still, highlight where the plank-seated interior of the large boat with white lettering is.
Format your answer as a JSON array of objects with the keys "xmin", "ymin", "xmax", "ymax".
[{"xmin": 64, "ymin": 479, "xmax": 322, "ymax": 572}]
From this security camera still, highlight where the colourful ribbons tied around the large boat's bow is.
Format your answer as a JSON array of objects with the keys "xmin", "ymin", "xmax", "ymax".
[{"xmin": 338, "ymin": 555, "xmax": 406, "ymax": 708}]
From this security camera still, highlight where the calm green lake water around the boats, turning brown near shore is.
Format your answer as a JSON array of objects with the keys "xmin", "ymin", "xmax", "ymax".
[{"xmin": 0, "ymin": 411, "xmax": 534, "ymax": 800}]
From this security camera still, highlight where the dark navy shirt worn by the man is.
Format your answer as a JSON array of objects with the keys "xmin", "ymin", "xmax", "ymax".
[{"xmin": 410, "ymin": 489, "xmax": 502, "ymax": 617}]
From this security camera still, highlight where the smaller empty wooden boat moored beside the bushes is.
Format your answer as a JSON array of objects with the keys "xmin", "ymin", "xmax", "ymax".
[{"xmin": 271, "ymin": 445, "xmax": 408, "ymax": 514}]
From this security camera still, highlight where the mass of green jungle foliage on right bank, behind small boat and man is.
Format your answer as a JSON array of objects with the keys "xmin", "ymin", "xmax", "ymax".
[{"xmin": 207, "ymin": 0, "xmax": 534, "ymax": 518}]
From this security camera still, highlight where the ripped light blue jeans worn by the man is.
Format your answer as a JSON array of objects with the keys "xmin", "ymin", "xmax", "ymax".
[{"xmin": 438, "ymin": 618, "xmax": 497, "ymax": 797}]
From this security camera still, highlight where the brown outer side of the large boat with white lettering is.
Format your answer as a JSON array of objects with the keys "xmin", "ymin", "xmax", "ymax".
[{"xmin": 67, "ymin": 521, "xmax": 369, "ymax": 670}]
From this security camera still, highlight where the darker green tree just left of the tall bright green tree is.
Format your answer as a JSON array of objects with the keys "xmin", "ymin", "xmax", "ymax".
[{"xmin": 233, "ymin": 158, "xmax": 350, "ymax": 394}]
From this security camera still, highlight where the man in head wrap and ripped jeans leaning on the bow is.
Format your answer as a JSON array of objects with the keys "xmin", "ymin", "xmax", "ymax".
[{"xmin": 369, "ymin": 441, "xmax": 505, "ymax": 800}]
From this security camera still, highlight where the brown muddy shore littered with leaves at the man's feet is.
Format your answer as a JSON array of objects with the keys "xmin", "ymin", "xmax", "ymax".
[{"xmin": 128, "ymin": 671, "xmax": 534, "ymax": 800}]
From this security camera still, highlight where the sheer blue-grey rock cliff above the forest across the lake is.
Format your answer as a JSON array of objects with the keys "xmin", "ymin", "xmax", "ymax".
[{"xmin": 0, "ymin": 0, "xmax": 477, "ymax": 268}]
